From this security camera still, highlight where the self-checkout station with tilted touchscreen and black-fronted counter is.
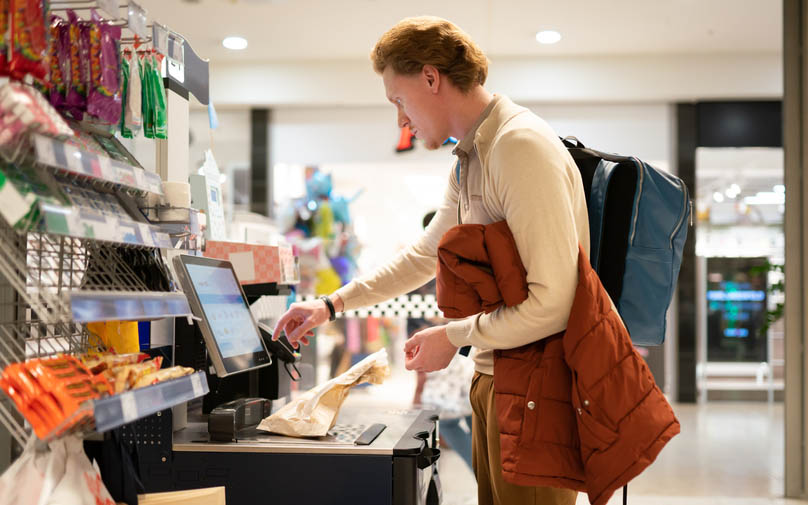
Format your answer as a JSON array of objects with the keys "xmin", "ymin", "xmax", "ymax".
[{"xmin": 129, "ymin": 257, "xmax": 442, "ymax": 505}]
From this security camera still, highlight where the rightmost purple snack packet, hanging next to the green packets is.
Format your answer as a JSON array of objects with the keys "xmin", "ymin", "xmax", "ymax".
[{"xmin": 87, "ymin": 11, "xmax": 121, "ymax": 125}]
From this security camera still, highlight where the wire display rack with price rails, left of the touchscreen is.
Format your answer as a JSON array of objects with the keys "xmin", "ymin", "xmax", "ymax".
[{"xmin": 0, "ymin": 0, "xmax": 215, "ymax": 446}]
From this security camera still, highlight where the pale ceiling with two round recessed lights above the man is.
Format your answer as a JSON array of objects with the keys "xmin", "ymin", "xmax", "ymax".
[{"xmin": 134, "ymin": 0, "xmax": 782, "ymax": 61}]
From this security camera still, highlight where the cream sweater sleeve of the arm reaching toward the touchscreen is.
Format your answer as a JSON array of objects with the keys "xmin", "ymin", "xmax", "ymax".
[{"xmin": 336, "ymin": 165, "xmax": 458, "ymax": 310}]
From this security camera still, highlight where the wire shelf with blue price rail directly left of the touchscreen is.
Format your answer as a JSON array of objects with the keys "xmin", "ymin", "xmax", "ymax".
[{"xmin": 0, "ymin": 216, "xmax": 191, "ymax": 324}]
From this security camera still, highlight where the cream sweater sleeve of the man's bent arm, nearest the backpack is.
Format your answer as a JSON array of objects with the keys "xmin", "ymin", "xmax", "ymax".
[{"xmin": 447, "ymin": 129, "xmax": 588, "ymax": 349}]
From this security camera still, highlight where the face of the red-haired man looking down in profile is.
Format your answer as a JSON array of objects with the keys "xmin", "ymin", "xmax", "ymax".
[{"xmin": 382, "ymin": 66, "xmax": 449, "ymax": 149}]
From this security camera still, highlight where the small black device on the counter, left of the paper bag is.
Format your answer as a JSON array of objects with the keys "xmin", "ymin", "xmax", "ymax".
[{"xmin": 208, "ymin": 398, "xmax": 272, "ymax": 442}]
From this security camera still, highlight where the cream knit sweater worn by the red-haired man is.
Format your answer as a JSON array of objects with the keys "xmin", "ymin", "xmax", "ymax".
[{"xmin": 337, "ymin": 97, "xmax": 589, "ymax": 375}]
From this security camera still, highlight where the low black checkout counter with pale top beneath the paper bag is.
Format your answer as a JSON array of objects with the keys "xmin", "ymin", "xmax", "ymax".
[{"xmin": 138, "ymin": 409, "xmax": 442, "ymax": 505}]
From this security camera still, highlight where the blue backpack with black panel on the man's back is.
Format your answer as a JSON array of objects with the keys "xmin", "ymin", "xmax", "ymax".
[{"xmin": 562, "ymin": 137, "xmax": 692, "ymax": 346}]
